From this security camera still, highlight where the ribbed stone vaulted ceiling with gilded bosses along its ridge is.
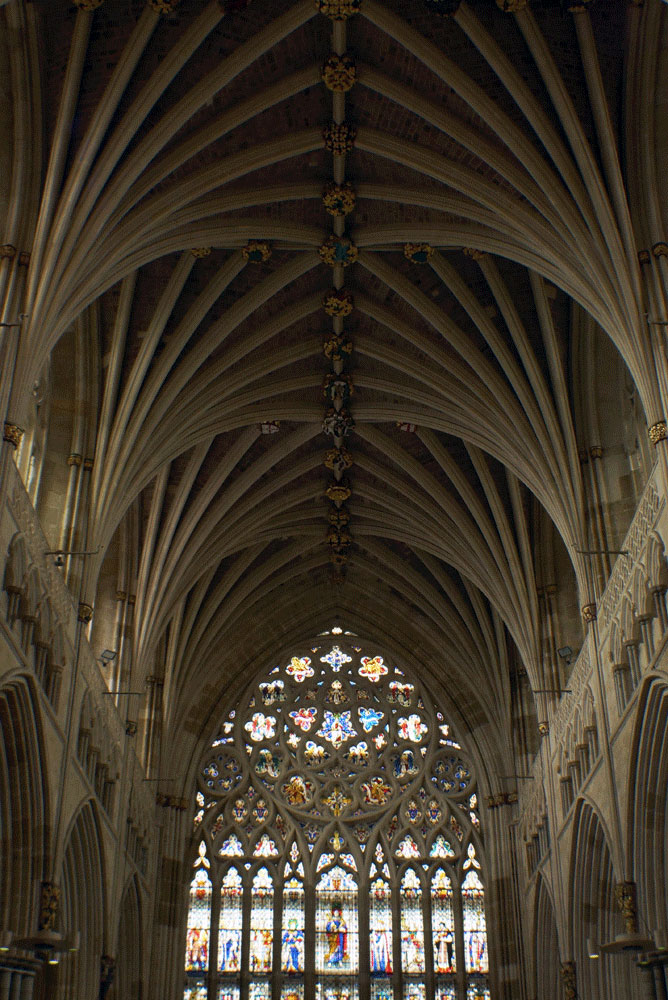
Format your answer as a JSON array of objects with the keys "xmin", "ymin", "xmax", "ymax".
[{"xmin": 4, "ymin": 0, "xmax": 665, "ymax": 780}]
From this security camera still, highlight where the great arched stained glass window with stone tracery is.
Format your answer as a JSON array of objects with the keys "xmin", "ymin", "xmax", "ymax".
[{"xmin": 184, "ymin": 634, "xmax": 490, "ymax": 1000}]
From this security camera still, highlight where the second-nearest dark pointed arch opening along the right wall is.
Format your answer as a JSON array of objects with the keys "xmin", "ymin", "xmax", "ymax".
[{"xmin": 570, "ymin": 799, "xmax": 636, "ymax": 1000}]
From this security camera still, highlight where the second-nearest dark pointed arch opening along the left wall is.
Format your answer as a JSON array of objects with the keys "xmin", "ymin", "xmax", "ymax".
[{"xmin": 56, "ymin": 801, "xmax": 104, "ymax": 1000}]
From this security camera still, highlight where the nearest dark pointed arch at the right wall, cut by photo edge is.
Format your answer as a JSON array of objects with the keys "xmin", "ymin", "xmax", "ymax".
[{"xmin": 628, "ymin": 681, "xmax": 668, "ymax": 930}]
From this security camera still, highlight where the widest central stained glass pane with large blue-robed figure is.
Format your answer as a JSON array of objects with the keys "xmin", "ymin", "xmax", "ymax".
[{"xmin": 316, "ymin": 865, "xmax": 358, "ymax": 972}]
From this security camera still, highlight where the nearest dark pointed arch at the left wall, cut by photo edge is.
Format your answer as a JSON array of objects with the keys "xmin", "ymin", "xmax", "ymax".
[{"xmin": 0, "ymin": 677, "xmax": 49, "ymax": 935}]
